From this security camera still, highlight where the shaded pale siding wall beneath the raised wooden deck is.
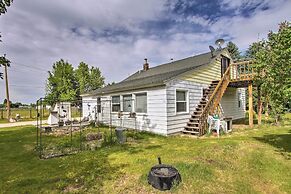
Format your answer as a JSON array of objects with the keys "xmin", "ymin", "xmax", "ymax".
[{"xmin": 220, "ymin": 88, "xmax": 246, "ymax": 120}]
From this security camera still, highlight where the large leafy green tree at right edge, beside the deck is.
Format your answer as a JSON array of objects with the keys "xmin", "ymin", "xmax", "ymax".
[{"xmin": 255, "ymin": 22, "xmax": 291, "ymax": 122}]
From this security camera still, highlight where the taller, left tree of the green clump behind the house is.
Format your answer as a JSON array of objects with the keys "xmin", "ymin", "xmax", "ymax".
[{"xmin": 46, "ymin": 59, "xmax": 77, "ymax": 104}]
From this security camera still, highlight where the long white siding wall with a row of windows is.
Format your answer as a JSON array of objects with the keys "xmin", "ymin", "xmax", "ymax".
[{"xmin": 83, "ymin": 87, "xmax": 167, "ymax": 135}]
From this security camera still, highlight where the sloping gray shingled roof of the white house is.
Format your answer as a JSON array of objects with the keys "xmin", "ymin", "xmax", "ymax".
[{"xmin": 82, "ymin": 49, "xmax": 224, "ymax": 96}]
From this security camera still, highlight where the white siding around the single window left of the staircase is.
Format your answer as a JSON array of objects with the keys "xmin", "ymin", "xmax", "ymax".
[{"xmin": 166, "ymin": 79, "xmax": 208, "ymax": 134}]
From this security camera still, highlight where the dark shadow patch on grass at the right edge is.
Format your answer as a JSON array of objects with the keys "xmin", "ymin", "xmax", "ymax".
[{"xmin": 254, "ymin": 130, "xmax": 291, "ymax": 159}]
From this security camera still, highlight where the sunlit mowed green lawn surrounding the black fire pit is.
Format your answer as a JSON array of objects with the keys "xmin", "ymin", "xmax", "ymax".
[{"xmin": 0, "ymin": 114, "xmax": 291, "ymax": 193}]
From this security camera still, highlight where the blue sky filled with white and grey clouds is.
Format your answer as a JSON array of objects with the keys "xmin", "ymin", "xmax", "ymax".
[{"xmin": 0, "ymin": 0, "xmax": 291, "ymax": 103}]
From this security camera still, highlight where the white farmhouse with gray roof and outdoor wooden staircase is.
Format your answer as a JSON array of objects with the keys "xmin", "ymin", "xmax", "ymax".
[{"xmin": 82, "ymin": 49, "xmax": 254, "ymax": 135}]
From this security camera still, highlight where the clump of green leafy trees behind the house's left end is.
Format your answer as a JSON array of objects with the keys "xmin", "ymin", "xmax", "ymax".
[{"xmin": 46, "ymin": 59, "xmax": 104, "ymax": 104}]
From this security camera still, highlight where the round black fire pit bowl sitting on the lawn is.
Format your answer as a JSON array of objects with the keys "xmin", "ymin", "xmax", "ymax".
[{"xmin": 148, "ymin": 164, "xmax": 181, "ymax": 191}]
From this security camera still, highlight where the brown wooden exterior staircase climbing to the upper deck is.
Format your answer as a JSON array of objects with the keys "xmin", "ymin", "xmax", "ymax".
[{"xmin": 182, "ymin": 66, "xmax": 231, "ymax": 136}]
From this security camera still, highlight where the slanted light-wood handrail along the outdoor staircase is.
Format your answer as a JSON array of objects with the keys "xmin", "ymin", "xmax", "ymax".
[{"xmin": 199, "ymin": 65, "xmax": 231, "ymax": 135}]
